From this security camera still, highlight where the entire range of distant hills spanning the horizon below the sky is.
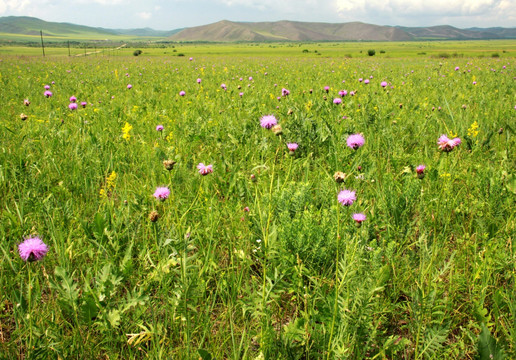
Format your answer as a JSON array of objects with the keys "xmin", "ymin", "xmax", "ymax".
[{"xmin": 0, "ymin": 16, "xmax": 516, "ymax": 42}]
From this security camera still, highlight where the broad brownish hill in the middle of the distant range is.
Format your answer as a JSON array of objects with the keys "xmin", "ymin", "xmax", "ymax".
[{"xmin": 169, "ymin": 20, "xmax": 412, "ymax": 41}]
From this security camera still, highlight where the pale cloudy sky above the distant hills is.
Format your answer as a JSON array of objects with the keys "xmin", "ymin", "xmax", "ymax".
[{"xmin": 0, "ymin": 0, "xmax": 516, "ymax": 30}]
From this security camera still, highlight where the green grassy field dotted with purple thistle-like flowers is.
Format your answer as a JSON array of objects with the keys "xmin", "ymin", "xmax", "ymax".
[{"xmin": 0, "ymin": 41, "xmax": 516, "ymax": 360}]
